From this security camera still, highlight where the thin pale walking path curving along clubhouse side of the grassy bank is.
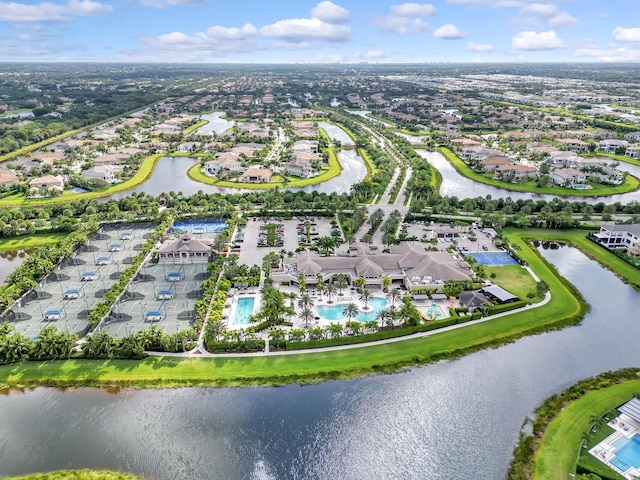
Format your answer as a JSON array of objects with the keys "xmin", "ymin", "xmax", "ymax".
[{"xmin": 147, "ymin": 290, "xmax": 551, "ymax": 358}]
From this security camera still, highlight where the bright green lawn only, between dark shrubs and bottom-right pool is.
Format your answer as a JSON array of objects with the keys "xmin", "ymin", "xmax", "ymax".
[{"xmin": 534, "ymin": 380, "xmax": 640, "ymax": 480}]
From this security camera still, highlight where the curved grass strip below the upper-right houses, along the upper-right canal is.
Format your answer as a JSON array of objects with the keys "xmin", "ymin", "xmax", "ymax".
[{"xmin": 438, "ymin": 147, "xmax": 640, "ymax": 197}]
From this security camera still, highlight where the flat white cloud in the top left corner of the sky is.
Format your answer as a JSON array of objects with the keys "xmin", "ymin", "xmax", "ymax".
[{"xmin": 0, "ymin": 0, "xmax": 113, "ymax": 22}]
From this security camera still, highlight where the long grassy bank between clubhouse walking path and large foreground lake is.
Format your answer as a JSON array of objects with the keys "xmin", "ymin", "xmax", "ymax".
[{"xmin": 0, "ymin": 229, "xmax": 624, "ymax": 388}]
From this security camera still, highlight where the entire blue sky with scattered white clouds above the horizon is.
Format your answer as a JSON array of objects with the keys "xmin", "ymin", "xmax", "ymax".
[{"xmin": 0, "ymin": 0, "xmax": 640, "ymax": 63}]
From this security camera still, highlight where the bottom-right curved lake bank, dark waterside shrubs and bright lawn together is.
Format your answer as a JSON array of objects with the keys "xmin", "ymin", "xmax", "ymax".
[{"xmin": 507, "ymin": 368, "xmax": 640, "ymax": 480}]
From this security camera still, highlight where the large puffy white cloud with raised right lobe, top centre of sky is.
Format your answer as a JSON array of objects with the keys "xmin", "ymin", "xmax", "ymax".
[{"xmin": 260, "ymin": 2, "xmax": 351, "ymax": 43}]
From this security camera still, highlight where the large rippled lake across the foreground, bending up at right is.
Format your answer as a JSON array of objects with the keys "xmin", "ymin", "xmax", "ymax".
[{"xmin": 0, "ymin": 248, "xmax": 640, "ymax": 480}]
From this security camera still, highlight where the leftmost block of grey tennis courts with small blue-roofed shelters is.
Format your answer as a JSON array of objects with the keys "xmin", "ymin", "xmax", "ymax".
[{"xmin": 5, "ymin": 224, "xmax": 155, "ymax": 337}]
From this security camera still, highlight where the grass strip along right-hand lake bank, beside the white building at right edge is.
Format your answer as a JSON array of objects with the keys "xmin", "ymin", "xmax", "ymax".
[{"xmin": 503, "ymin": 228, "xmax": 640, "ymax": 290}]
